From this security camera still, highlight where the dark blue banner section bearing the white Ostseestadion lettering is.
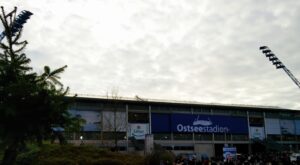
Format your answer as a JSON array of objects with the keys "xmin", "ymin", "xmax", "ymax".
[{"xmin": 171, "ymin": 114, "xmax": 248, "ymax": 134}]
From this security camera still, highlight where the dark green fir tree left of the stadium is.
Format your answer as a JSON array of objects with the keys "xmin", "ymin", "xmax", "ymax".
[{"xmin": 0, "ymin": 7, "xmax": 70, "ymax": 165}]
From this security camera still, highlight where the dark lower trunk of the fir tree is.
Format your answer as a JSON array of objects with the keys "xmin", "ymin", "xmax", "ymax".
[{"xmin": 1, "ymin": 141, "xmax": 19, "ymax": 165}]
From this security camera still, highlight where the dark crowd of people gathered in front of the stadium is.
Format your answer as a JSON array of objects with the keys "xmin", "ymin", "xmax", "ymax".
[{"xmin": 173, "ymin": 152, "xmax": 300, "ymax": 165}]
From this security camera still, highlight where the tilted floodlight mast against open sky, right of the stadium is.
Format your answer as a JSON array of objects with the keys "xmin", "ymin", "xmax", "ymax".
[{"xmin": 259, "ymin": 46, "xmax": 300, "ymax": 89}]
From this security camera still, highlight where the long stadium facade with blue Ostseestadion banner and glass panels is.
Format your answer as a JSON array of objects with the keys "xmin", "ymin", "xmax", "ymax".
[{"xmin": 65, "ymin": 96, "xmax": 300, "ymax": 157}]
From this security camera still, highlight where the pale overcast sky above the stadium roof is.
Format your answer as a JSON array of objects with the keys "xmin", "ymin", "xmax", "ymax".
[{"xmin": 1, "ymin": 0, "xmax": 300, "ymax": 110}]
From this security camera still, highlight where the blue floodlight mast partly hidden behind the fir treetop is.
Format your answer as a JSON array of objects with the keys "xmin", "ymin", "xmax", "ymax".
[{"xmin": 0, "ymin": 6, "xmax": 33, "ymax": 42}]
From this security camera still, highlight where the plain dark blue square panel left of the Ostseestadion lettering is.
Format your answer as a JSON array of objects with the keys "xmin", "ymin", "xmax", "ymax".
[{"xmin": 151, "ymin": 113, "xmax": 171, "ymax": 133}]
